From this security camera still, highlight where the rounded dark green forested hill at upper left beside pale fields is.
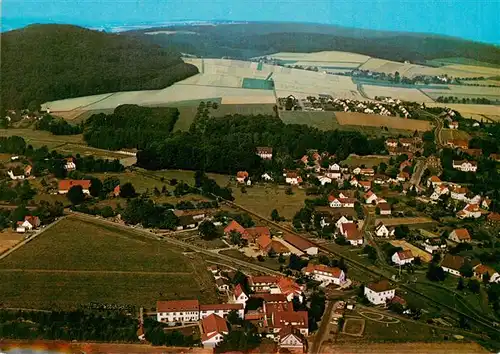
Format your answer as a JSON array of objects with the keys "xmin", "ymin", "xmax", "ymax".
[{"xmin": 0, "ymin": 25, "xmax": 198, "ymax": 108}]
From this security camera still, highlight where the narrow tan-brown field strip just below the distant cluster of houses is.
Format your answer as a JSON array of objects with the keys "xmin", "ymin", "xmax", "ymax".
[{"xmin": 335, "ymin": 112, "xmax": 431, "ymax": 131}]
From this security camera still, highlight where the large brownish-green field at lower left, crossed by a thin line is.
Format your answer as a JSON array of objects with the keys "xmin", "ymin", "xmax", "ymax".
[{"xmin": 0, "ymin": 217, "xmax": 216, "ymax": 309}]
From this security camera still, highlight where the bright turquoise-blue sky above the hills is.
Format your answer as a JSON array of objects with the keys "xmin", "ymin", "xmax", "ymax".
[{"xmin": 0, "ymin": 0, "xmax": 500, "ymax": 45}]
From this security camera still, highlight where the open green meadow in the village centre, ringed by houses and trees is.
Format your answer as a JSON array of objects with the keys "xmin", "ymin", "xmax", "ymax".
[{"xmin": 233, "ymin": 185, "xmax": 307, "ymax": 219}]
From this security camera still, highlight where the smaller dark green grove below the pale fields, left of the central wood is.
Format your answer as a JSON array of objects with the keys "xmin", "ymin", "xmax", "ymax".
[{"xmin": 84, "ymin": 105, "xmax": 179, "ymax": 150}]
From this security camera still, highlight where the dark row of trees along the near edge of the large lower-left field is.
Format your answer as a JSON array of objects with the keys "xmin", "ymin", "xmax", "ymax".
[{"xmin": 0, "ymin": 309, "xmax": 139, "ymax": 342}]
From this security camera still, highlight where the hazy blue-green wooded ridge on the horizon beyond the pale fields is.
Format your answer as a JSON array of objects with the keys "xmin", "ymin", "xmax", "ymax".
[{"xmin": 128, "ymin": 23, "xmax": 500, "ymax": 64}]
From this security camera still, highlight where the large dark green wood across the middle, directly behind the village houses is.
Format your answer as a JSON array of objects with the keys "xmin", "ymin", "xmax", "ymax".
[{"xmin": 137, "ymin": 115, "xmax": 384, "ymax": 175}]
